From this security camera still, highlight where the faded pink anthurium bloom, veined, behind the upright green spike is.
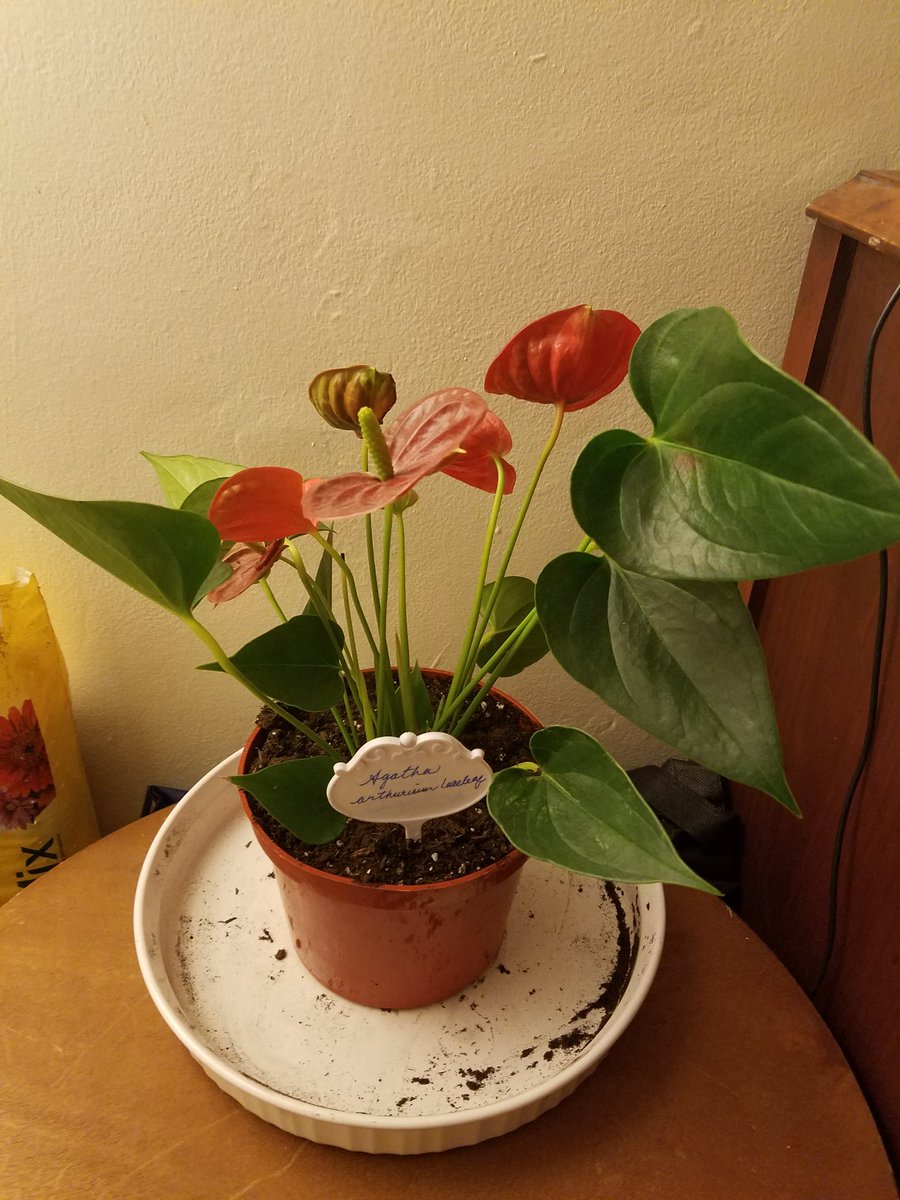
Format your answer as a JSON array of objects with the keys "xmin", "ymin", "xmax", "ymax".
[{"xmin": 305, "ymin": 388, "xmax": 497, "ymax": 521}]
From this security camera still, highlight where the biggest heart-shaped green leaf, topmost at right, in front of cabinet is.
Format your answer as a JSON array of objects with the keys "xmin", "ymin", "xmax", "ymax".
[{"xmin": 572, "ymin": 308, "xmax": 900, "ymax": 580}]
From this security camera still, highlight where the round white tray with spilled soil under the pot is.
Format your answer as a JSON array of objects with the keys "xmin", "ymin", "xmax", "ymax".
[{"xmin": 134, "ymin": 755, "xmax": 665, "ymax": 1154}]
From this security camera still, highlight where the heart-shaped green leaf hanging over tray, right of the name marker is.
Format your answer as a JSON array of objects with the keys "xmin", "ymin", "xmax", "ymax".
[{"xmin": 487, "ymin": 725, "xmax": 715, "ymax": 892}]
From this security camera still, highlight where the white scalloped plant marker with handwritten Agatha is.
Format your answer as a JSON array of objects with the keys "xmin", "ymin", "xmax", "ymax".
[{"xmin": 328, "ymin": 733, "xmax": 493, "ymax": 841}]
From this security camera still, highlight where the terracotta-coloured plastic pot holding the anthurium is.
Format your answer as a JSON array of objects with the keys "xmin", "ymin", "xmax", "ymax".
[{"xmin": 240, "ymin": 694, "xmax": 536, "ymax": 1008}]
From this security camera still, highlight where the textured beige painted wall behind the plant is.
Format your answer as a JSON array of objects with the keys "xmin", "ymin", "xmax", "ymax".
[{"xmin": 0, "ymin": 0, "xmax": 898, "ymax": 828}]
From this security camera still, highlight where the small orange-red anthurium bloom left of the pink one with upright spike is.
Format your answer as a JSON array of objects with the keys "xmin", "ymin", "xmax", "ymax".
[{"xmin": 209, "ymin": 467, "xmax": 316, "ymax": 541}]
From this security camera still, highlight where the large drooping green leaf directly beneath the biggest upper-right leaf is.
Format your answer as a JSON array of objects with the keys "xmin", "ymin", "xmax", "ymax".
[{"xmin": 538, "ymin": 552, "xmax": 799, "ymax": 812}]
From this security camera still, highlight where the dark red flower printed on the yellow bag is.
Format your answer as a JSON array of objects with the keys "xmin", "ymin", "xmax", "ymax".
[{"xmin": 0, "ymin": 700, "xmax": 56, "ymax": 829}]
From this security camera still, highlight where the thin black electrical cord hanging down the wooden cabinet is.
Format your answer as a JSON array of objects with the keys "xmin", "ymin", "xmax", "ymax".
[{"xmin": 809, "ymin": 278, "xmax": 900, "ymax": 997}]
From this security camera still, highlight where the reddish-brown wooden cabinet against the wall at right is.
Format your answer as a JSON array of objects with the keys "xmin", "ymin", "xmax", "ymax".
[{"xmin": 732, "ymin": 172, "xmax": 900, "ymax": 1163}]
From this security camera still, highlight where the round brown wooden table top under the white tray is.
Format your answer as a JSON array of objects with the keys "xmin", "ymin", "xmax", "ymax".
[{"xmin": 0, "ymin": 814, "xmax": 896, "ymax": 1200}]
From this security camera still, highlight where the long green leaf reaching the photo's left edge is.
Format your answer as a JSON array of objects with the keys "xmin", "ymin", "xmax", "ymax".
[{"xmin": 0, "ymin": 480, "xmax": 220, "ymax": 617}]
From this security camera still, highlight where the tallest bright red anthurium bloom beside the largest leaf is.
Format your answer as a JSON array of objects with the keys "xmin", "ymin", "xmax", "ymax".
[{"xmin": 485, "ymin": 305, "xmax": 641, "ymax": 413}]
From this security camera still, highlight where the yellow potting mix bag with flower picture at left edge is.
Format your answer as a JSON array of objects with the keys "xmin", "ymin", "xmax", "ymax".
[{"xmin": 0, "ymin": 571, "xmax": 98, "ymax": 904}]
